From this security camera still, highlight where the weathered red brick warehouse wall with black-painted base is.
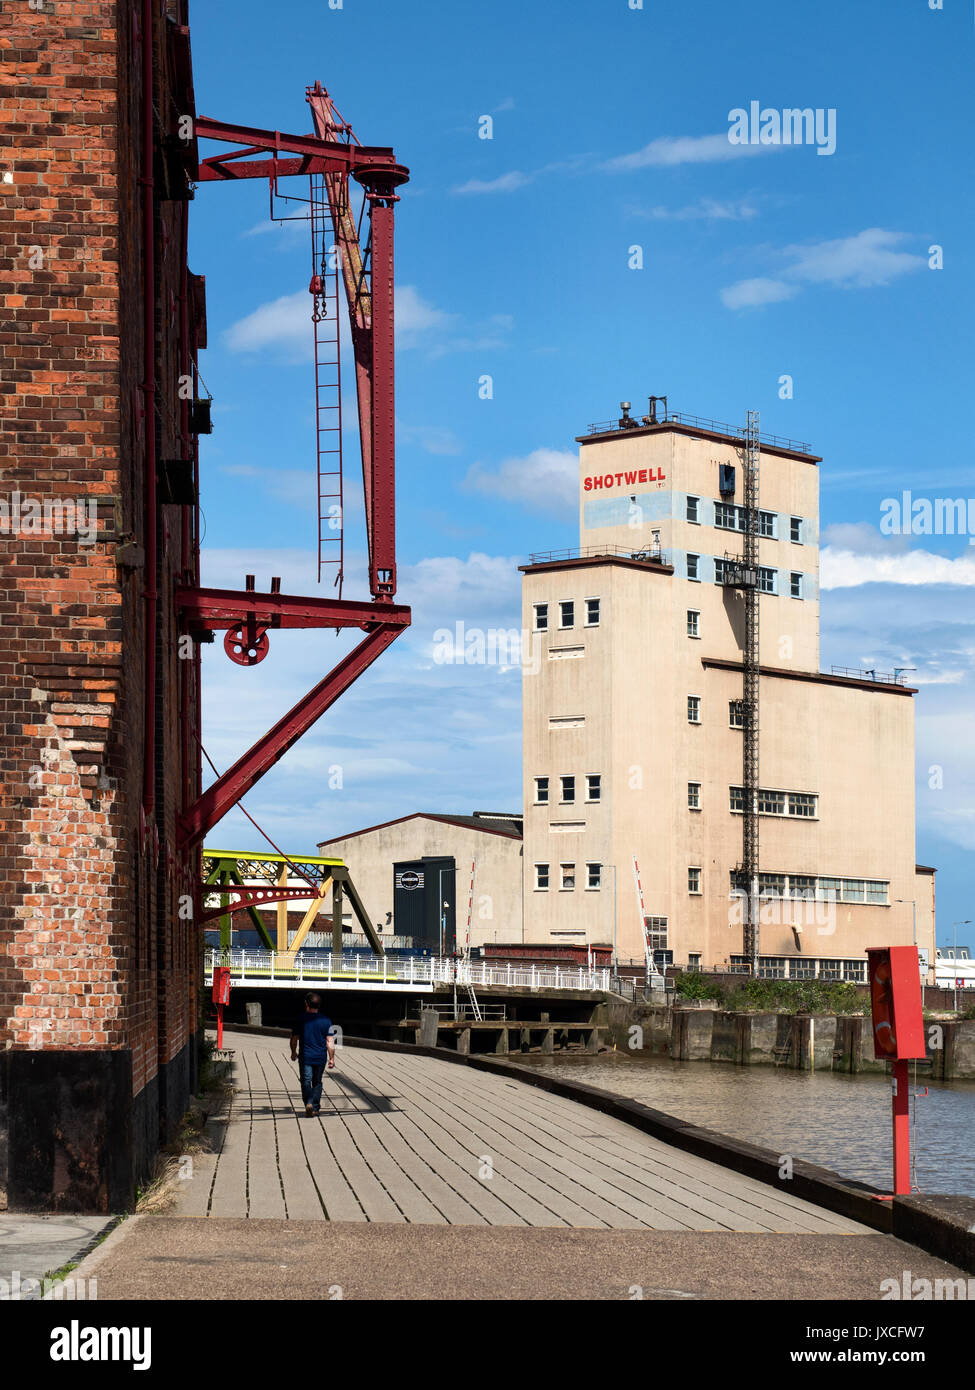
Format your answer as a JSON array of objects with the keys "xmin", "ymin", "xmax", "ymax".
[{"xmin": 0, "ymin": 0, "xmax": 204, "ymax": 1211}]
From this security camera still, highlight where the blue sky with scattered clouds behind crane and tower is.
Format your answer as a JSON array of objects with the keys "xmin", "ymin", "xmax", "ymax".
[{"xmin": 191, "ymin": 0, "xmax": 975, "ymax": 944}]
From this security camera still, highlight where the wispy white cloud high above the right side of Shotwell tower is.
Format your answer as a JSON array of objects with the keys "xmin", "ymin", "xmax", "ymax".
[{"xmin": 720, "ymin": 227, "xmax": 928, "ymax": 309}]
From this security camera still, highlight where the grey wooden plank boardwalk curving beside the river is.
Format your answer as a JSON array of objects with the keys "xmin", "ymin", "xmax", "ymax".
[{"xmin": 172, "ymin": 1034, "xmax": 871, "ymax": 1236}]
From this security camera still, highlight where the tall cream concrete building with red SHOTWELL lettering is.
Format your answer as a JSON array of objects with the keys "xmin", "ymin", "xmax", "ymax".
[{"xmin": 523, "ymin": 407, "xmax": 935, "ymax": 980}]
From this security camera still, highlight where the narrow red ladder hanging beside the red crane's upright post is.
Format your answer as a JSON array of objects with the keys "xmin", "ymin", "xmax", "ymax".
[{"xmin": 309, "ymin": 174, "xmax": 344, "ymax": 598}]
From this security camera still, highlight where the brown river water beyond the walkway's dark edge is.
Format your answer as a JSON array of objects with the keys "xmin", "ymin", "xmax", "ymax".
[{"xmin": 506, "ymin": 1051, "xmax": 975, "ymax": 1197}]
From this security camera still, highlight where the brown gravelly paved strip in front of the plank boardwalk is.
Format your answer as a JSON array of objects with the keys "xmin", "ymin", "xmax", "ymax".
[{"xmin": 76, "ymin": 1216, "xmax": 964, "ymax": 1301}]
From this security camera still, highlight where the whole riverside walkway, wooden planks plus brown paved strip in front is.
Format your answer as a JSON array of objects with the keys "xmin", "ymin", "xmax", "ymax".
[{"xmin": 68, "ymin": 1033, "xmax": 961, "ymax": 1301}]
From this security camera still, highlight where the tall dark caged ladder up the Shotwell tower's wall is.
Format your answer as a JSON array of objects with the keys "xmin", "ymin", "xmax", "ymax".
[{"xmin": 741, "ymin": 410, "xmax": 761, "ymax": 976}]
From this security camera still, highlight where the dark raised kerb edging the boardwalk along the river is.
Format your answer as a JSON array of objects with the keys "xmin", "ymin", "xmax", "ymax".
[{"xmin": 214, "ymin": 1027, "xmax": 975, "ymax": 1273}]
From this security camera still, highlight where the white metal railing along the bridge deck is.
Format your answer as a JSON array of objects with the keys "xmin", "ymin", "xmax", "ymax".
[{"xmin": 203, "ymin": 948, "xmax": 611, "ymax": 990}]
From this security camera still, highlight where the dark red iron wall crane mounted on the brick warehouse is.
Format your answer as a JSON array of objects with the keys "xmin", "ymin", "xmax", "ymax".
[{"xmin": 177, "ymin": 82, "xmax": 410, "ymax": 853}]
